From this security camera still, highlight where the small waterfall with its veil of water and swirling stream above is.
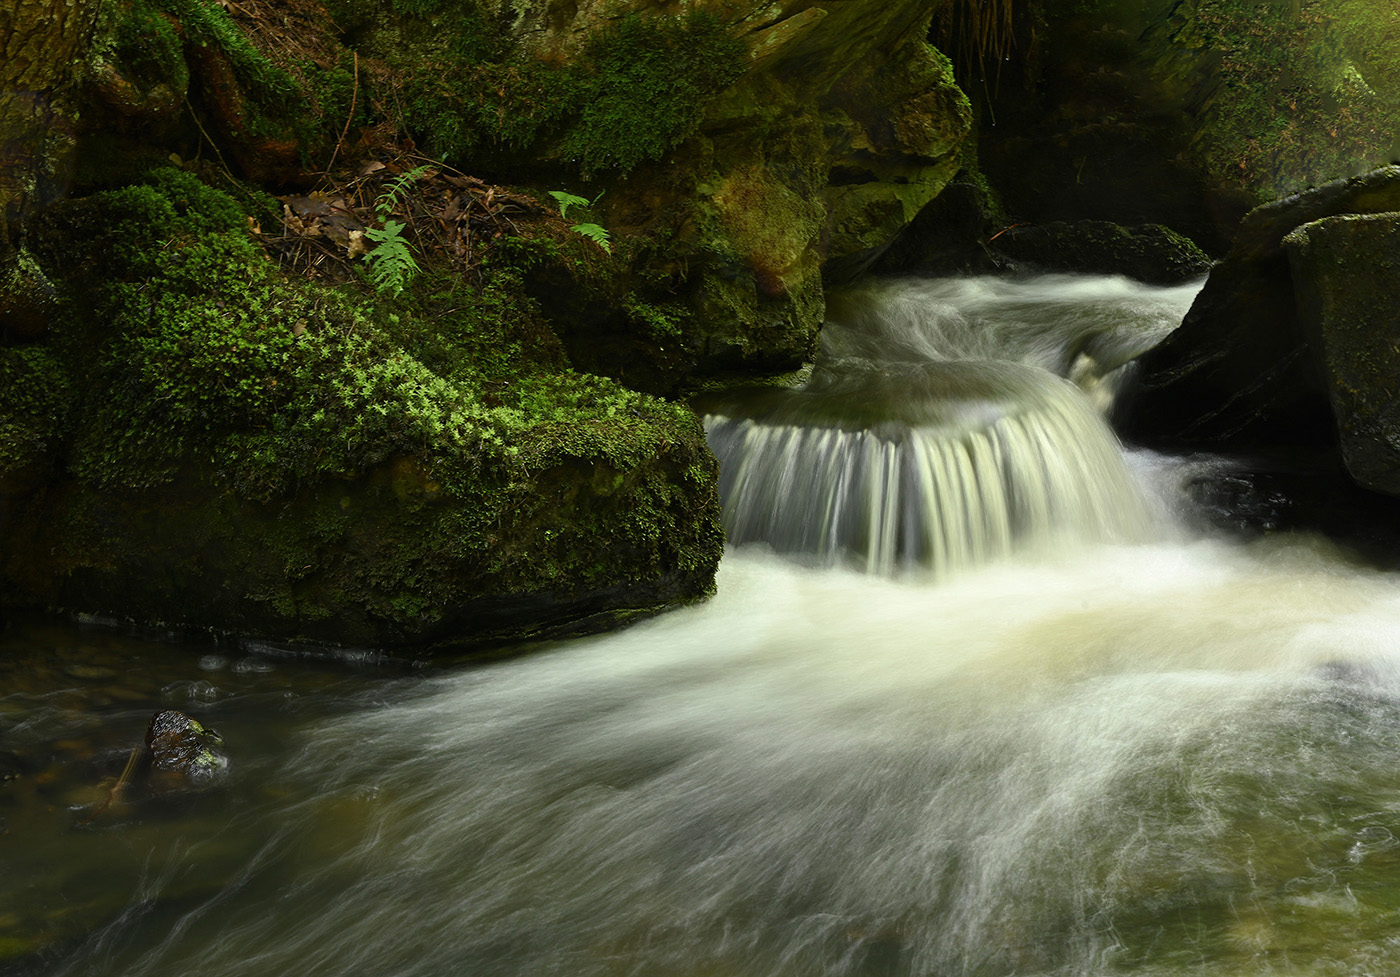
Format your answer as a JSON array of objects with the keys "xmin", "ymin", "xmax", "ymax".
[{"xmin": 703, "ymin": 270, "xmax": 1190, "ymax": 574}]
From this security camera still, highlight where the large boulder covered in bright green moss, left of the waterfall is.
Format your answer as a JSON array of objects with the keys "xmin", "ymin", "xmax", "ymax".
[{"xmin": 0, "ymin": 169, "xmax": 722, "ymax": 648}]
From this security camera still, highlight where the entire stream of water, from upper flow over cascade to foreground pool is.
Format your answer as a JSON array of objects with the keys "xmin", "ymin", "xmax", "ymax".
[{"xmin": 8, "ymin": 279, "xmax": 1400, "ymax": 977}]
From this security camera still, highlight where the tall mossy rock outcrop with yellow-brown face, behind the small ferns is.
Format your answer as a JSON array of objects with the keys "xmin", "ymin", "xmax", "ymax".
[{"xmin": 334, "ymin": 0, "xmax": 972, "ymax": 392}]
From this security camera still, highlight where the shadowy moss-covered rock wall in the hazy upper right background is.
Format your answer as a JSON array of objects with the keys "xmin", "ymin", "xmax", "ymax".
[{"xmin": 981, "ymin": 0, "xmax": 1400, "ymax": 255}]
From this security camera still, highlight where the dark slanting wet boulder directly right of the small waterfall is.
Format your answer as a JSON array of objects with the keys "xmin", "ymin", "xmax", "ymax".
[{"xmin": 1114, "ymin": 167, "xmax": 1400, "ymax": 448}]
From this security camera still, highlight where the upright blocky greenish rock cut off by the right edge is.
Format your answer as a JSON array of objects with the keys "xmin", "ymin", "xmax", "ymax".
[{"xmin": 1284, "ymin": 214, "xmax": 1400, "ymax": 495}]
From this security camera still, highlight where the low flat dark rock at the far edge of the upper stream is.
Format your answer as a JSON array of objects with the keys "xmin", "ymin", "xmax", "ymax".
[{"xmin": 991, "ymin": 221, "xmax": 1211, "ymax": 286}]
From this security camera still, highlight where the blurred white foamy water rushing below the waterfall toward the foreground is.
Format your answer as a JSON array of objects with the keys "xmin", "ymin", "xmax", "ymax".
[{"xmin": 43, "ymin": 543, "xmax": 1400, "ymax": 977}]
